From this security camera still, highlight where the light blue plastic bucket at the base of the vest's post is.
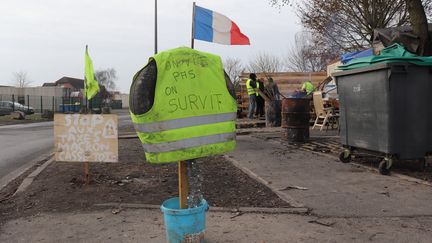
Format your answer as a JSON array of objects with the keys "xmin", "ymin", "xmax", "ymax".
[{"xmin": 161, "ymin": 197, "xmax": 209, "ymax": 243}]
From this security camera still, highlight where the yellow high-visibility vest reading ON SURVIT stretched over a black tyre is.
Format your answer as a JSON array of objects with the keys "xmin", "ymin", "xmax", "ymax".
[{"xmin": 129, "ymin": 47, "xmax": 237, "ymax": 163}]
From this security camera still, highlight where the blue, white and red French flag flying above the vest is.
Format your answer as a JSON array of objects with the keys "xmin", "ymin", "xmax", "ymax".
[{"xmin": 194, "ymin": 6, "xmax": 250, "ymax": 45}]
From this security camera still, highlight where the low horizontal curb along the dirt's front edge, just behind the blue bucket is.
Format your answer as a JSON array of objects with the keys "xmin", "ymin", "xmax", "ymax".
[{"xmin": 93, "ymin": 203, "xmax": 309, "ymax": 214}]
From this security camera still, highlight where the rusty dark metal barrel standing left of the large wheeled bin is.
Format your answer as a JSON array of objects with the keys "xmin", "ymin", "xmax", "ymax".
[{"xmin": 281, "ymin": 98, "xmax": 310, "ymax": 142}]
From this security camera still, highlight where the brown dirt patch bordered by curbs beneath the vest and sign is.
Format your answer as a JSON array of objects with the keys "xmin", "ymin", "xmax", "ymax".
[{"xmin": 0, "ymin": 139, "xmax": 289, "ymax": 225}]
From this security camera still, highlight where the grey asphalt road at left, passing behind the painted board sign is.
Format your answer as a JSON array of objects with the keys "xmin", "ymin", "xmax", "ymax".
[{"xmin": 0, "ymin": 110, "xmax": 131, "ymax": 184}]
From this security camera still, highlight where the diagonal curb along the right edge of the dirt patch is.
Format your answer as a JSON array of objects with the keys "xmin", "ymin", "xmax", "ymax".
[{"xmin": 223, "ymin": 155, "xmax": 306, "ymax": 208}]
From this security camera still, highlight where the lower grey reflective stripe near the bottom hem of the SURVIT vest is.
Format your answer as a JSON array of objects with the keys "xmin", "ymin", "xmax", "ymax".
[{"xmin": 143, "ymin": 133, "xmax": 235, "ymax": 153}]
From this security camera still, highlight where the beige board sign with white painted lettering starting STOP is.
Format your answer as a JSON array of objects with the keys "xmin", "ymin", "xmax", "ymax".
[{"xmin": 54, "ymin": 114, "xmax": 118, "ymax": 162}]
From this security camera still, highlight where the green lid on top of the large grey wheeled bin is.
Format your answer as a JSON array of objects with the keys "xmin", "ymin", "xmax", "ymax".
[{"xmin": 337, "ymin": 43, "xmax": 432, "ymax": 70}]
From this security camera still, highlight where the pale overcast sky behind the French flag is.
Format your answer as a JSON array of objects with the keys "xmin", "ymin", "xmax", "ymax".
[{"xmin": 0, "ymin": 0, "xmax": 301, "ymax": 93}]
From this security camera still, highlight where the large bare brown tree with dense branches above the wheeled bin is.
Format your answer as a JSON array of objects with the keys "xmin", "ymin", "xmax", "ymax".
[{"xmin": 269, "ymin": 0, "xmax": 432, "ymax": 55}]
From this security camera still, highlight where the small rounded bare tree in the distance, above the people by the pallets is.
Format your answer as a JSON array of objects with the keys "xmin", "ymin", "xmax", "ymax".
[{"xmin": 248, "ymin": 52, "xmax": 283, "ymax": 73}]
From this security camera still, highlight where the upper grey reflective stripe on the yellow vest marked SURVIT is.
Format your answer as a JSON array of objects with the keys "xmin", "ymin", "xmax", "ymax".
[{"xmin": 134, "ymin": 112, "xmax": 237, "ymax": 133}]
